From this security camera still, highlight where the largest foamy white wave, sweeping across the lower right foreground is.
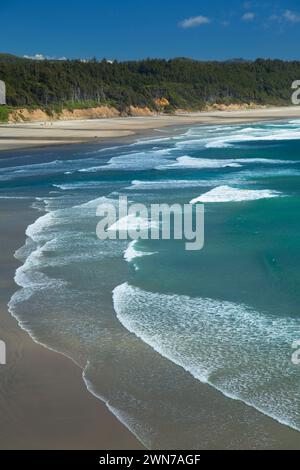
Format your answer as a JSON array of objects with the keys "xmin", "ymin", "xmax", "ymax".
[{"xmin": 113, "ymin": 283, "xmax": 300, "ymax": 429}]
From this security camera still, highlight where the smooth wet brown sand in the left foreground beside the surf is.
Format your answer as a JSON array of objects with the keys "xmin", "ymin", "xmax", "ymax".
[{"xmin": 0, "ymin": 200, "xmax": 143, "ymax": 450}]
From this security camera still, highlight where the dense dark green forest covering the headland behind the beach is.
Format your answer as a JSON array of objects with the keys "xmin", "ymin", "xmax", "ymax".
[{"xmin": 0, "ymin": 54, "xmax": 300, "ymax": 114}]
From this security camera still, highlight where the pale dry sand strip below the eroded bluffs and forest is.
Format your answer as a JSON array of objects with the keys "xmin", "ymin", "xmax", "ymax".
[{"xmin": 0, "ymin": 106, "xmax": 300, "ymax": 151}]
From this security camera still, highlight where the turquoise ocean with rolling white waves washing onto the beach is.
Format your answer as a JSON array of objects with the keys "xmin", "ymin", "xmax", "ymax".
[{"xmin": 0, "ymin": 120, "xmax": 300, "ymax": 449}]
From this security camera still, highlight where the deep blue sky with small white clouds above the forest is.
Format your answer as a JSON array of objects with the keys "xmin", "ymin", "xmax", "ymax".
[{"xmin": 0, "ymin": 0, "xmax": 300, "ymax": 60}]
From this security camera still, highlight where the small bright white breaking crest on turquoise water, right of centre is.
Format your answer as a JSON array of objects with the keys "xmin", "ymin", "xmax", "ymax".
[{"xmin": 190, "ymin": 186, "xmax": 281, "ymax": 204}]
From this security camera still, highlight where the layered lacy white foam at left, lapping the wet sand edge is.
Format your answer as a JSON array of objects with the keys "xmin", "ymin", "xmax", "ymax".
[{"xmin": 13, "ymin": 197, "xmax": 122, "ymax": 290}]
